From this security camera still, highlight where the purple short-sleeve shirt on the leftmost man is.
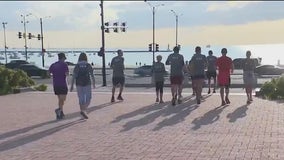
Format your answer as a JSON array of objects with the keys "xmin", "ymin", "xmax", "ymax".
[{"xmin": 49, "ymin": 61, "xmax": 69, "ymax": 87}]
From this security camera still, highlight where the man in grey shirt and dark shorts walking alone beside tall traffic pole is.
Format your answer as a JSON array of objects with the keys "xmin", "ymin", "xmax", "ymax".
[{"xmin": 110, "ymin": 49, "xmax": 125, "ymax": 102}]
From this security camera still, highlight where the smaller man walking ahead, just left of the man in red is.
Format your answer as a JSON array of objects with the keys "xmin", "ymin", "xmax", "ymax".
[{"xmin": 206, "ymin": 50, "xmax": 217, "ymax": 94}]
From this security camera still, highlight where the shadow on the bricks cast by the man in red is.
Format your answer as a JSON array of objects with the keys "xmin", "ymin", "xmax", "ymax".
[{"xmin": 192, "ymin": 105, "xmax": 228, "ymax": 130}]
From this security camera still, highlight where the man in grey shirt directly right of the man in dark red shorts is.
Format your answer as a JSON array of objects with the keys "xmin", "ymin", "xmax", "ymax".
[{"xmin": 189, "ymin": 46, "xmax": 207, "ymax": 104}]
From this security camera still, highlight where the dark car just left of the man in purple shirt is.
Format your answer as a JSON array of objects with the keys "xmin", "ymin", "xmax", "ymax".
[{"xmin": 18, "ymin": 64, "xmax": 50, "ymax": 78}]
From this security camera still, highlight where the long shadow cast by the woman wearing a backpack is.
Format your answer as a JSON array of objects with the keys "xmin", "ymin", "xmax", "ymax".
[{"xmin": 0, "ymin": 119, "xmax": 85, "ymax": 152}]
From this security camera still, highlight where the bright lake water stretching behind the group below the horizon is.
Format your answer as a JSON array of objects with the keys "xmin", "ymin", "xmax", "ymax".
[{"xmin": 0, "ymin": 44, "xmax": 284, "ymax": 67}]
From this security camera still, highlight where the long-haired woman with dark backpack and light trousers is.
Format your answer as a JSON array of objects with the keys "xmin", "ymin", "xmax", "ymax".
[{"xmin": 70, "ymin": 53, "xmax": 95, "ymax": 119}]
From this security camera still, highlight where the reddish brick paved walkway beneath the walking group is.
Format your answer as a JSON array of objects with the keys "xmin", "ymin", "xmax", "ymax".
[{"xmin": 0, "ymin": 89, "xmax": 284, "ymax": 160}]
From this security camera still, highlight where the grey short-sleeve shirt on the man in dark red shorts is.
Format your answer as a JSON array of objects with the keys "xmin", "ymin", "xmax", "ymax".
[{"xmin": 166, "ymin": 53, "xmax": 184, "ymax": 76}]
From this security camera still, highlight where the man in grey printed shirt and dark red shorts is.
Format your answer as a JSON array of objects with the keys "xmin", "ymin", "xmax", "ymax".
[{"xmin": 166, "ymin": 46, "xmax": 184, "ymax": 105}]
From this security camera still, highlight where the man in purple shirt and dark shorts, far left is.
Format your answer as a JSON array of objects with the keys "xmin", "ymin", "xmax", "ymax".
[{"xmin": 49, "ymin": 53, "xmax": 69, "ymax": 119}]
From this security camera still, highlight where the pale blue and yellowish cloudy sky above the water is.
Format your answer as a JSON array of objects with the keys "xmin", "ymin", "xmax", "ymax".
[{"xmin": 0, "ymin": 0, "xmax": 284, "ymax": 49}]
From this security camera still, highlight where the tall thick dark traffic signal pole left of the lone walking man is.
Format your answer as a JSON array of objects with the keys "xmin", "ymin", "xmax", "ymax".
[{"xmin": 100, "ymin": 0, "xmax": 107, "ymax": 86}]
